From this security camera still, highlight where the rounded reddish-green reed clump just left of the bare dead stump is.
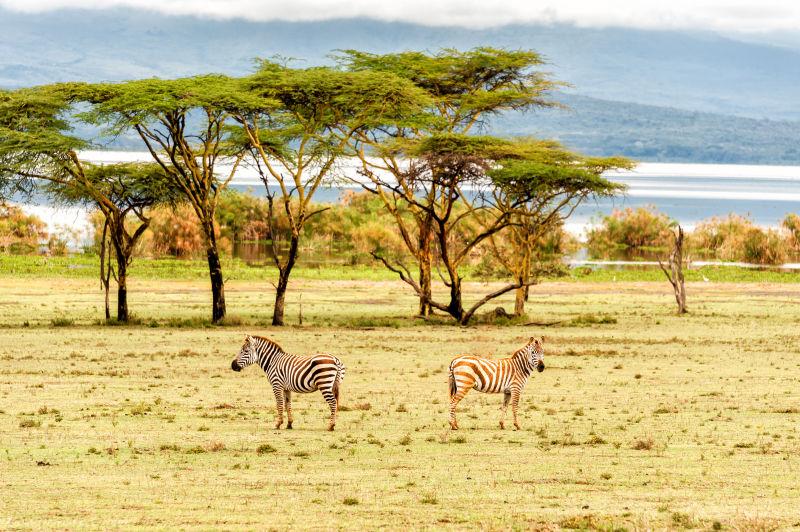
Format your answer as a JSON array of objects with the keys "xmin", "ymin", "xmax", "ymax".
[{"xmin": 587, "ymin": 206, "xmax": 675, "ymax": 254}]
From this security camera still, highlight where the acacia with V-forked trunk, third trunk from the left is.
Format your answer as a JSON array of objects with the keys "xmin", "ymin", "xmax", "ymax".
[{"xmin": 234, "ymin": 61, "xmax": 425, "ymax": 325}]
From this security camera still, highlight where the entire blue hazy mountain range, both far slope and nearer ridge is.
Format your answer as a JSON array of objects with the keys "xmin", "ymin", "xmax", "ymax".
[{"xmin": 0, "ymin": 9, "xmax": 800, "ymax": 164}]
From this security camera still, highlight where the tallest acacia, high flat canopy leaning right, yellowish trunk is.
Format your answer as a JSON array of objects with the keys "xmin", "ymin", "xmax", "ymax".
[{"xmin": 338, "ymin": 48, "xmax": 559, "ymax": 316}]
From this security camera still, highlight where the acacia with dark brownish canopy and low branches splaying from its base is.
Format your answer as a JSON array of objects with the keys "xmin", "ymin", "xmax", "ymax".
[{"xmin": 366, "ymin": 134, "xmax": 608, "ymax": 325}]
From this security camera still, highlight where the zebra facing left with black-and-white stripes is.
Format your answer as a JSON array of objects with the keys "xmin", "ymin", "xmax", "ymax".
[{"xmin": 231, "ymin": 335, "xmax": 345, "ymax": 430}]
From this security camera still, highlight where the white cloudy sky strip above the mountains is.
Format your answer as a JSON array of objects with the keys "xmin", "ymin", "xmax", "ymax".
[{"xmin": 0, "ymin": 0, "xmax": 800, "ymax": 34}]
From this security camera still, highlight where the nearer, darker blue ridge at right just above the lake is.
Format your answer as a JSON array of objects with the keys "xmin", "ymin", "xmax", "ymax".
[{"xmin": 494, "ymin": 95, "xmax": 800, "ymax": 165}]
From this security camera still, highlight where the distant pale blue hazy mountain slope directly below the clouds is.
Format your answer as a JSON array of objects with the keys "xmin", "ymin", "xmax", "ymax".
[{"xmin": 0, "ymin": 9, "xmax": 800, "ymax": 119}]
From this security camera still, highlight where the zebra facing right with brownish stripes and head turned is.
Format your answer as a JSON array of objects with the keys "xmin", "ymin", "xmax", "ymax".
[{"xmin": 449, "ymin": 337, "xmax": 544, "ymax": 430}]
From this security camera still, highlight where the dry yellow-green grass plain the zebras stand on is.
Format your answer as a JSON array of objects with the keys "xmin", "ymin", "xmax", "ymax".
[{"xmin": 0, "ymin": 268, "xmax": 800, "ymax": 530}]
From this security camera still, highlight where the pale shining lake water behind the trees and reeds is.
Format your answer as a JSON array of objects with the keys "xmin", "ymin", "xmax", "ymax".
[{"xmin": 12, "ymin": 151, "xmax": 800, "ymax": 248}]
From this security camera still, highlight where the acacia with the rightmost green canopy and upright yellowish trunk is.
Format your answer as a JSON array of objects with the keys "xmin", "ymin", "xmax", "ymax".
[{"xmin": 489, "ymin": 144, "xmax": 633, "ymax": 316}]
